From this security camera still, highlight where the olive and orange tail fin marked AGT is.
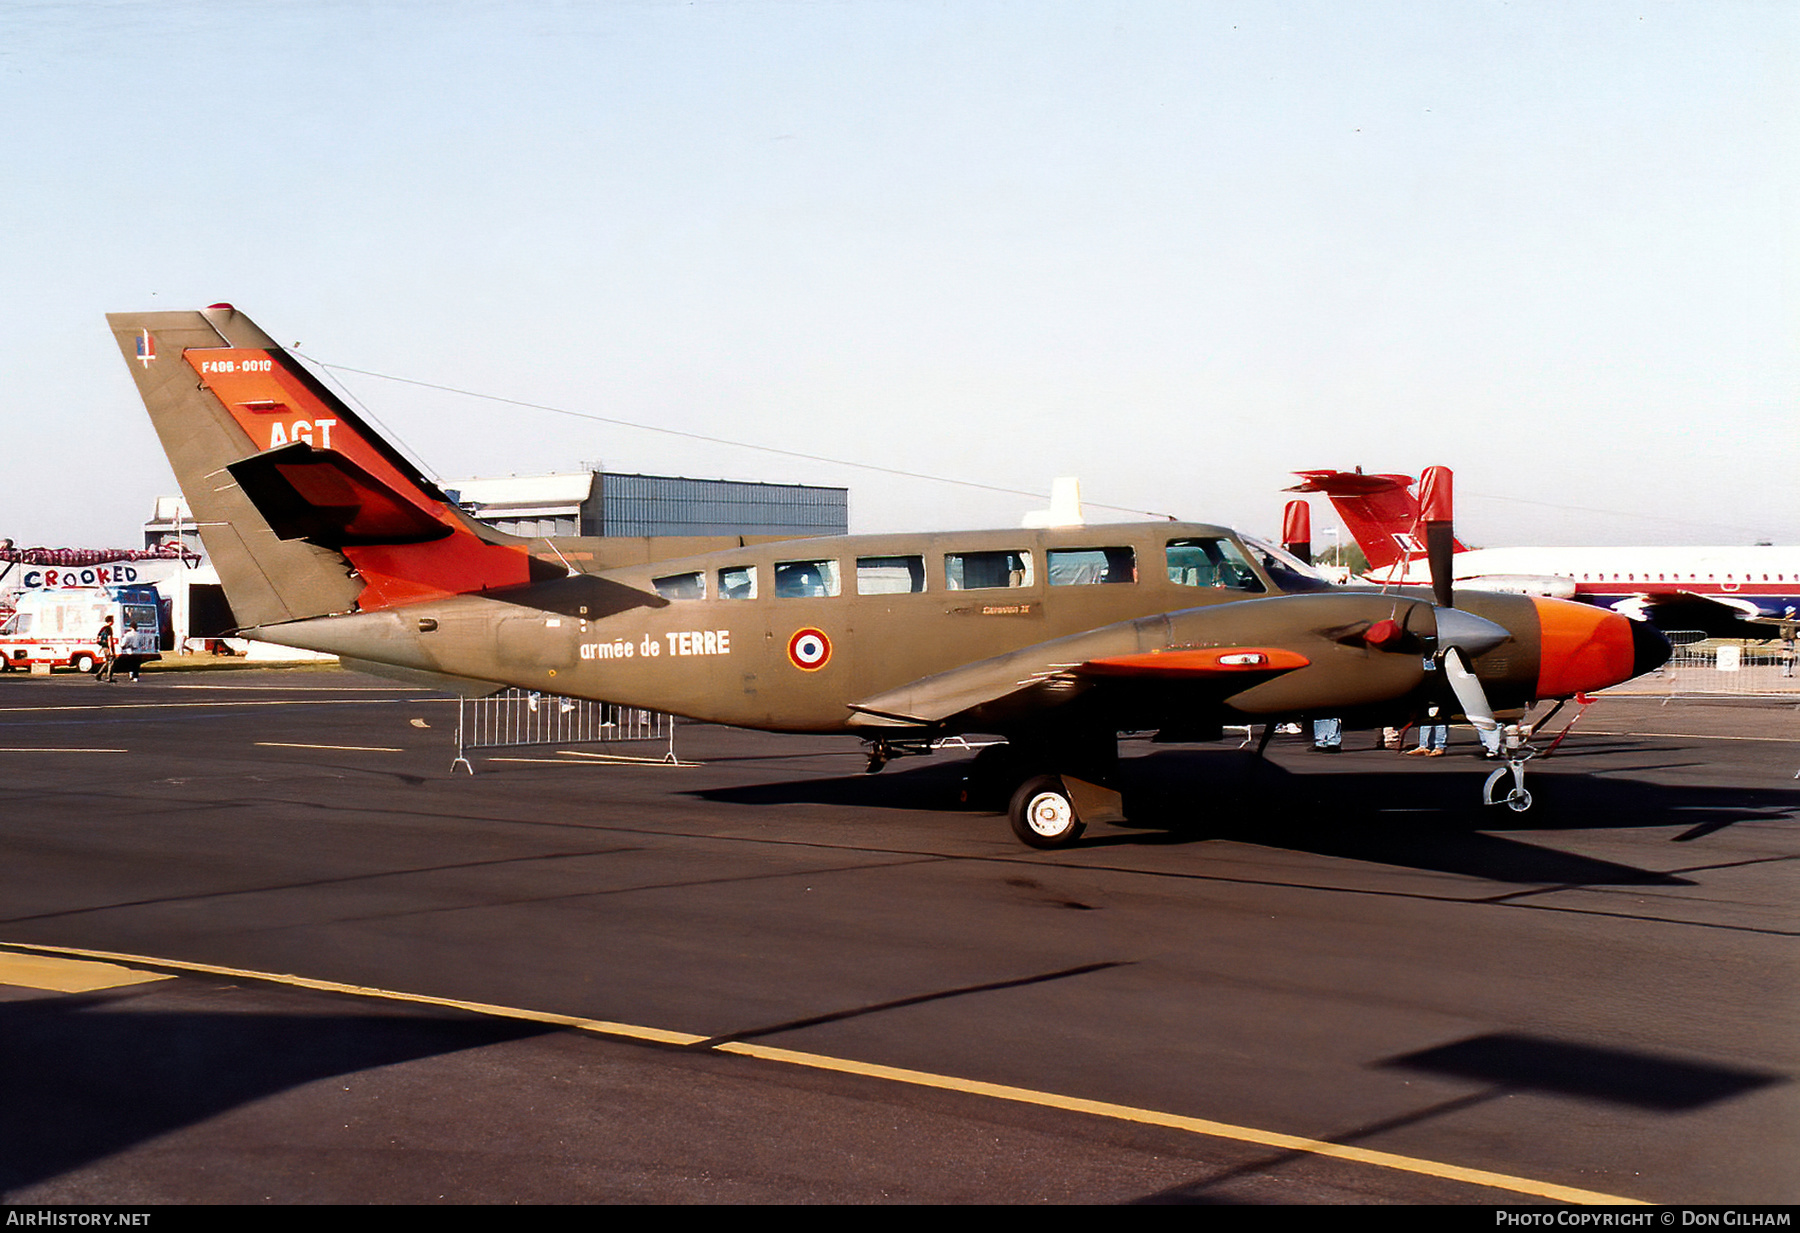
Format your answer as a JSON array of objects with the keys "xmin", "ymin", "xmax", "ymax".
[{"xmin": 106, "ymin": 304, "xmax": 542, "ymax": 628}]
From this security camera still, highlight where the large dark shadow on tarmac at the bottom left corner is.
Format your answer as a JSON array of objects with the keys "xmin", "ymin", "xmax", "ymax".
[{"xmin": 0, "ymin": 994, "xmax": 554, "ymax": 1195}]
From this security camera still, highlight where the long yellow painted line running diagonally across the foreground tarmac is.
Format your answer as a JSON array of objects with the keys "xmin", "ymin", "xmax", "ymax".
[{"xmin": 0, "ymin": 941, "xmax": 1645, "ymax": 1206}]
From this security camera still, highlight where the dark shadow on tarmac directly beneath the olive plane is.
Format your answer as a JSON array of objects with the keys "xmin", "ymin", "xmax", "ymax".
[{"xmin": 695, "ymin": 745, "xmax": 1800, "ymax": 886}]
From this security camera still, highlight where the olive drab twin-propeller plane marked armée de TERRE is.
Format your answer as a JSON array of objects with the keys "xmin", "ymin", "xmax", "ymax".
[{"xmin": 108, "ymin": 304, "xmax": 1669, "ymax": 848}]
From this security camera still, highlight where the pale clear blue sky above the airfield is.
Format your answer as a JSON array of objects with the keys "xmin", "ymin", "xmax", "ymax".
[{"xmin": 0, "ymin": 0, "xmax": 1800, "ymax": 547}]
